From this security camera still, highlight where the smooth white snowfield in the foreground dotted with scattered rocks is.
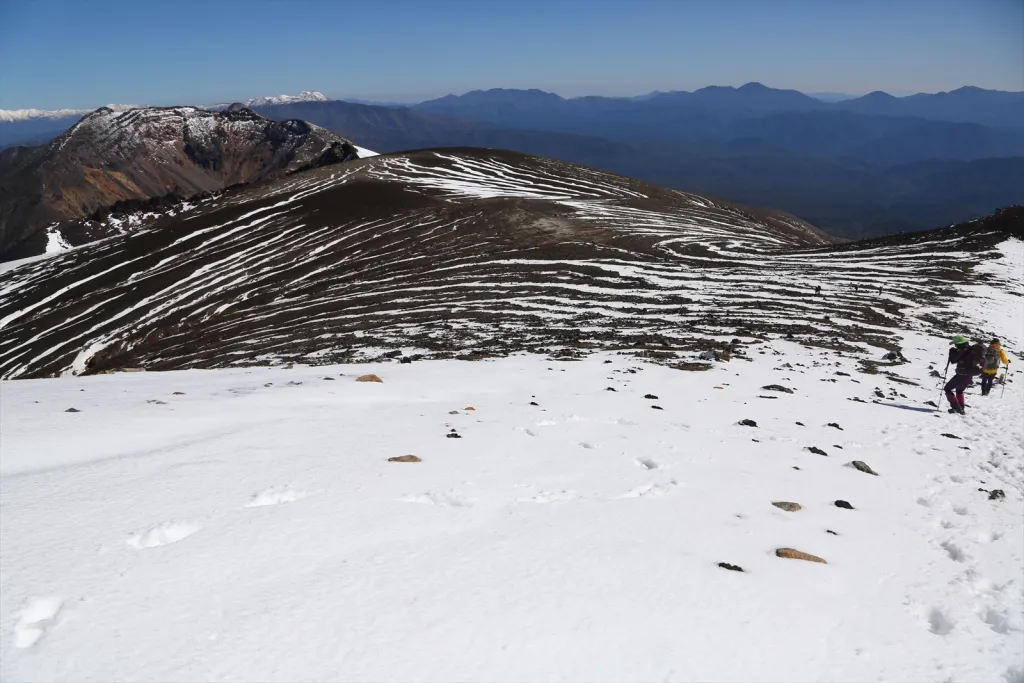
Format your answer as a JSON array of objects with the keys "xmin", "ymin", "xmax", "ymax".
[{"xmin": 0, "ymin": 325, "xmax": 1024, "ymax": 683}]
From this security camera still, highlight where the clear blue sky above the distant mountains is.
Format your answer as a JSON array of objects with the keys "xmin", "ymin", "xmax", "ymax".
[{"xmin": 0, "ymin": 0, "xmax": 1024, "ymax": 109}]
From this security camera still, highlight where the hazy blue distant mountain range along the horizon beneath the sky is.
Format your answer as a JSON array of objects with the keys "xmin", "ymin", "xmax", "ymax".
[{"xmin": 0, "ymin": 83, "xmax": 1024, "ymax": 238}]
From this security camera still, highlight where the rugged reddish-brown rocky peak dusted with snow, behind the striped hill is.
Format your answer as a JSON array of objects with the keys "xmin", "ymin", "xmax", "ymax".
[{"xmin": 0, "ymin": 106, "xmax": 364, "ymax": 258}]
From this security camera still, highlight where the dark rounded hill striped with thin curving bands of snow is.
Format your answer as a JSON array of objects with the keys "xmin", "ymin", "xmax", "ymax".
[{"xmin": 0, "ymin": 150, "xmax": 1004, "ymax": 378}]
